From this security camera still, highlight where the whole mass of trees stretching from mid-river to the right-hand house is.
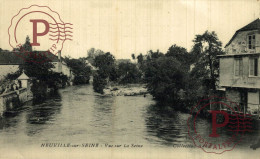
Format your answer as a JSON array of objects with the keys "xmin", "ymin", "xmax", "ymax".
[{"xmin": 90, "ymin": 31, "xmax": 224, "ymax": 105}]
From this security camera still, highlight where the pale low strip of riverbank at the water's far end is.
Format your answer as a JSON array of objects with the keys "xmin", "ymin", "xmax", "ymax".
[{"xmin": 104, "ymin": 84, "xmax": 149, "ymax": 96}]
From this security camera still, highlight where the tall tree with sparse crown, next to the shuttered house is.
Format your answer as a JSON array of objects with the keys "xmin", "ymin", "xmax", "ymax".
[{"xmin": 191, "ymin": 31, "xmax": 224, "ymax": 91}]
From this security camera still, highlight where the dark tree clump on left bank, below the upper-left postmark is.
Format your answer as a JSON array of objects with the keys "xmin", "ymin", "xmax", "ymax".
[{"xmin": 16, "ymin": 36, "xmax": 68, "ymax": 101}]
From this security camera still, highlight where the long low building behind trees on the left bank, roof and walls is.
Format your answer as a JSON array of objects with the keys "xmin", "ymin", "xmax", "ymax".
[{"xmin": 0, "ymin": 51, "xmax": 73, "ymax": 80}]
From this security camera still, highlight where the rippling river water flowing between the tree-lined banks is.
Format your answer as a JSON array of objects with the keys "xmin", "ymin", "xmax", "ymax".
[{"xmin": 0, "ymin": 85, "xmax": 259, "ymax": 148}]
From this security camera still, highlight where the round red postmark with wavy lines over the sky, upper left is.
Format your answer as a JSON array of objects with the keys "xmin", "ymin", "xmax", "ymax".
[{"xmin": 8, "ymin": 5, "xmax": 73, "ymax": 62}]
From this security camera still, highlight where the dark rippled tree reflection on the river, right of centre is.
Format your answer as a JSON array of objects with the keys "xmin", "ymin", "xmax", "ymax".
[{"xmin": 145, "ymin": 105, "xmax": 190, "ymax": 146}]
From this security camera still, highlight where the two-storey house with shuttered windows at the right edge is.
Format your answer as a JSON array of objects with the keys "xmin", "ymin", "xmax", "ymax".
[{"xmin": 219, "ymin": 19, "xmax": 260, "ymax": 117}]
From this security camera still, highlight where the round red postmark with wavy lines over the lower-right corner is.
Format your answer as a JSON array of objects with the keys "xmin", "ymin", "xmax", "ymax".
[{"xmin": 187, "ymin": 97, "xmax": 252, "ymax": 154}]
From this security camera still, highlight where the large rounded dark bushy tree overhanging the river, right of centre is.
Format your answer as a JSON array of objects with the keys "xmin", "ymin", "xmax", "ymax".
[{"xmin": 145, "ymin": 56, "xmax": 185, "ymax": 102}]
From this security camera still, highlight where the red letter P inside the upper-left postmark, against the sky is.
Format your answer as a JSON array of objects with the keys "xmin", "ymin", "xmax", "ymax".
[{"xmin": 30, "ymin": 19, "xmax": 50, "ymax": 46}]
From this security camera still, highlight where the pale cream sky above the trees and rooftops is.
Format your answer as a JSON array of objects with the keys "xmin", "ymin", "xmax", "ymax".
[{"xmin": 0, "ymin": 0, "xmax": 260, "ymax": 59}]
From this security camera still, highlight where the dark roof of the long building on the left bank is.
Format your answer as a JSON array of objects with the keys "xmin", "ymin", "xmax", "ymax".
[{"xmin": 0, "ymin": 51, "xmax": 60, "ymax": 65}]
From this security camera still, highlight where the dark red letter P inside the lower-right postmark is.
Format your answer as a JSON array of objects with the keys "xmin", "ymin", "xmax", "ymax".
[{"xmin": 209, "ymin": 110, "xmax": 229, "ymax": 137}]
